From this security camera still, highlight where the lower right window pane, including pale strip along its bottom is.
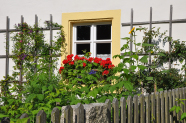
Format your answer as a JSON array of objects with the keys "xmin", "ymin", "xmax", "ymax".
[{"xmin": 96, "ymin": 43, "xmax": 111, "ymax": 60}]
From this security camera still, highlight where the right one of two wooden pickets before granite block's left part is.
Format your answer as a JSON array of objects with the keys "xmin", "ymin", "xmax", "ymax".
[{"xmin": 75, "ymin": 103, "xmax": 85, "ymax": 123}]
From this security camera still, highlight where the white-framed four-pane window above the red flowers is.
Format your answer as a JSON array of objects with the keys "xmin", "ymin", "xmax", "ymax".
[{"xmin": 72, "ymin": 22, "xmax": 112, "ymax": 60}]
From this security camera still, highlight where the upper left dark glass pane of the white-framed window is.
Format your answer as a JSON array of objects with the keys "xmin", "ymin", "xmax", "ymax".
[{"xmin": 77, "ymin": 25, "xmax": 90, "ymax": 40}]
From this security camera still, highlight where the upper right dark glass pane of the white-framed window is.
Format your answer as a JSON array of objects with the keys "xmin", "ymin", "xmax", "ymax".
[{"xmin": 96, "ymin": 24, "xmax": 111, "ymax": 40}]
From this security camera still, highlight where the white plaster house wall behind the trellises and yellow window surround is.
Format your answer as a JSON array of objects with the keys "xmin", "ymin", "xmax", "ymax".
[{"xmin": 0, "ymin": 0, "xmax": 186, "ymax": 94}]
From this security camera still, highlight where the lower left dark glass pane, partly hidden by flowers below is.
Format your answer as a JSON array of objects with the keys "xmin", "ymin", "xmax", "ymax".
[{"xmin": 76, "ymin": 44, "xmax": 90, "ymax": 55}]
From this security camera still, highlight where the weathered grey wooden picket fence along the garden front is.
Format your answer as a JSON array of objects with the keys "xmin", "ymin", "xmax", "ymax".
[{"xmin": 1, "ymin": 87, "xmax": 186, "ymax": 123}]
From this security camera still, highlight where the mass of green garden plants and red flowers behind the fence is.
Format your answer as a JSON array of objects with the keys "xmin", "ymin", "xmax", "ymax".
[{"xmin": 0, "ymin": 22, "xmax": 186, "ymax": 123}]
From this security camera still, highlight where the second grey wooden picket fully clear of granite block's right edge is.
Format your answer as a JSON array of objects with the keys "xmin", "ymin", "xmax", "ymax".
[{"xmin": 120, "ymin": 97, "xmax": 126, "ymax": 123}]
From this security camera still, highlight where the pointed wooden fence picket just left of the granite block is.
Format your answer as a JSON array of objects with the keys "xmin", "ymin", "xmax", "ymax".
[{"xmin": 51, "ymin": 107, "xmax": 60, "ymax": 123}]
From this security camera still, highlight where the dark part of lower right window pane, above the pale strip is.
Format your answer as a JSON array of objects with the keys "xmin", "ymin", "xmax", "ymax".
[{"xmin": 96, "ymin": 43, "xmax": 111, "ymax": 54}]
